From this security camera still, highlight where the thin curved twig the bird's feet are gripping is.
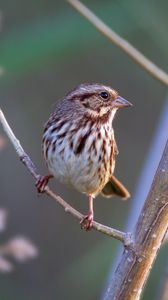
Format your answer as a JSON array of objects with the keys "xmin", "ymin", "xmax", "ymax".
[{"xmin": 0, "ymin": 109, "xmax": 132, "ymax": 246}]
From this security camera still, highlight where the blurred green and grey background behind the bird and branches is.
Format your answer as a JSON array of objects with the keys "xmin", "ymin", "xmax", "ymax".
[{"xmin": 0, "ymin": 0, "xmax": 168, "ymax": 300}]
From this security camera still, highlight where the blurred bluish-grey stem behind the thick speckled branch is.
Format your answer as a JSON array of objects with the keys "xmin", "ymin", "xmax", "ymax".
[{"xmin": 101, "ymin": 98, "xmax": 168, "ymax": 299}]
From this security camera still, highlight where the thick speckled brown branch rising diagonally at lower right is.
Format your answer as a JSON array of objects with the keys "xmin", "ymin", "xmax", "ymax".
[{"xmin": 104, "ymin": 142, "xmax": 168, "ymax": 300}]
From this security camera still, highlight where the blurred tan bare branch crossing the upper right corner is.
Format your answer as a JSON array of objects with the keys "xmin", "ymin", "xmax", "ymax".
[{"xmin": 67, "ymin": 0, "xmax": 168, "ymax": 86}]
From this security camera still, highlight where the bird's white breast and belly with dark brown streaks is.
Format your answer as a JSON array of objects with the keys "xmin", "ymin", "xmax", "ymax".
[{"xmin": 43, "ymin": 120, "xmax": 115, "ymax": 194}]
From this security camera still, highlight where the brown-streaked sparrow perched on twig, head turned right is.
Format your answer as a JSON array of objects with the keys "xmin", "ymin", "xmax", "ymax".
[{"xmin": 36, "ymin": 84, "xmax": 132, "ymax": 230}]
